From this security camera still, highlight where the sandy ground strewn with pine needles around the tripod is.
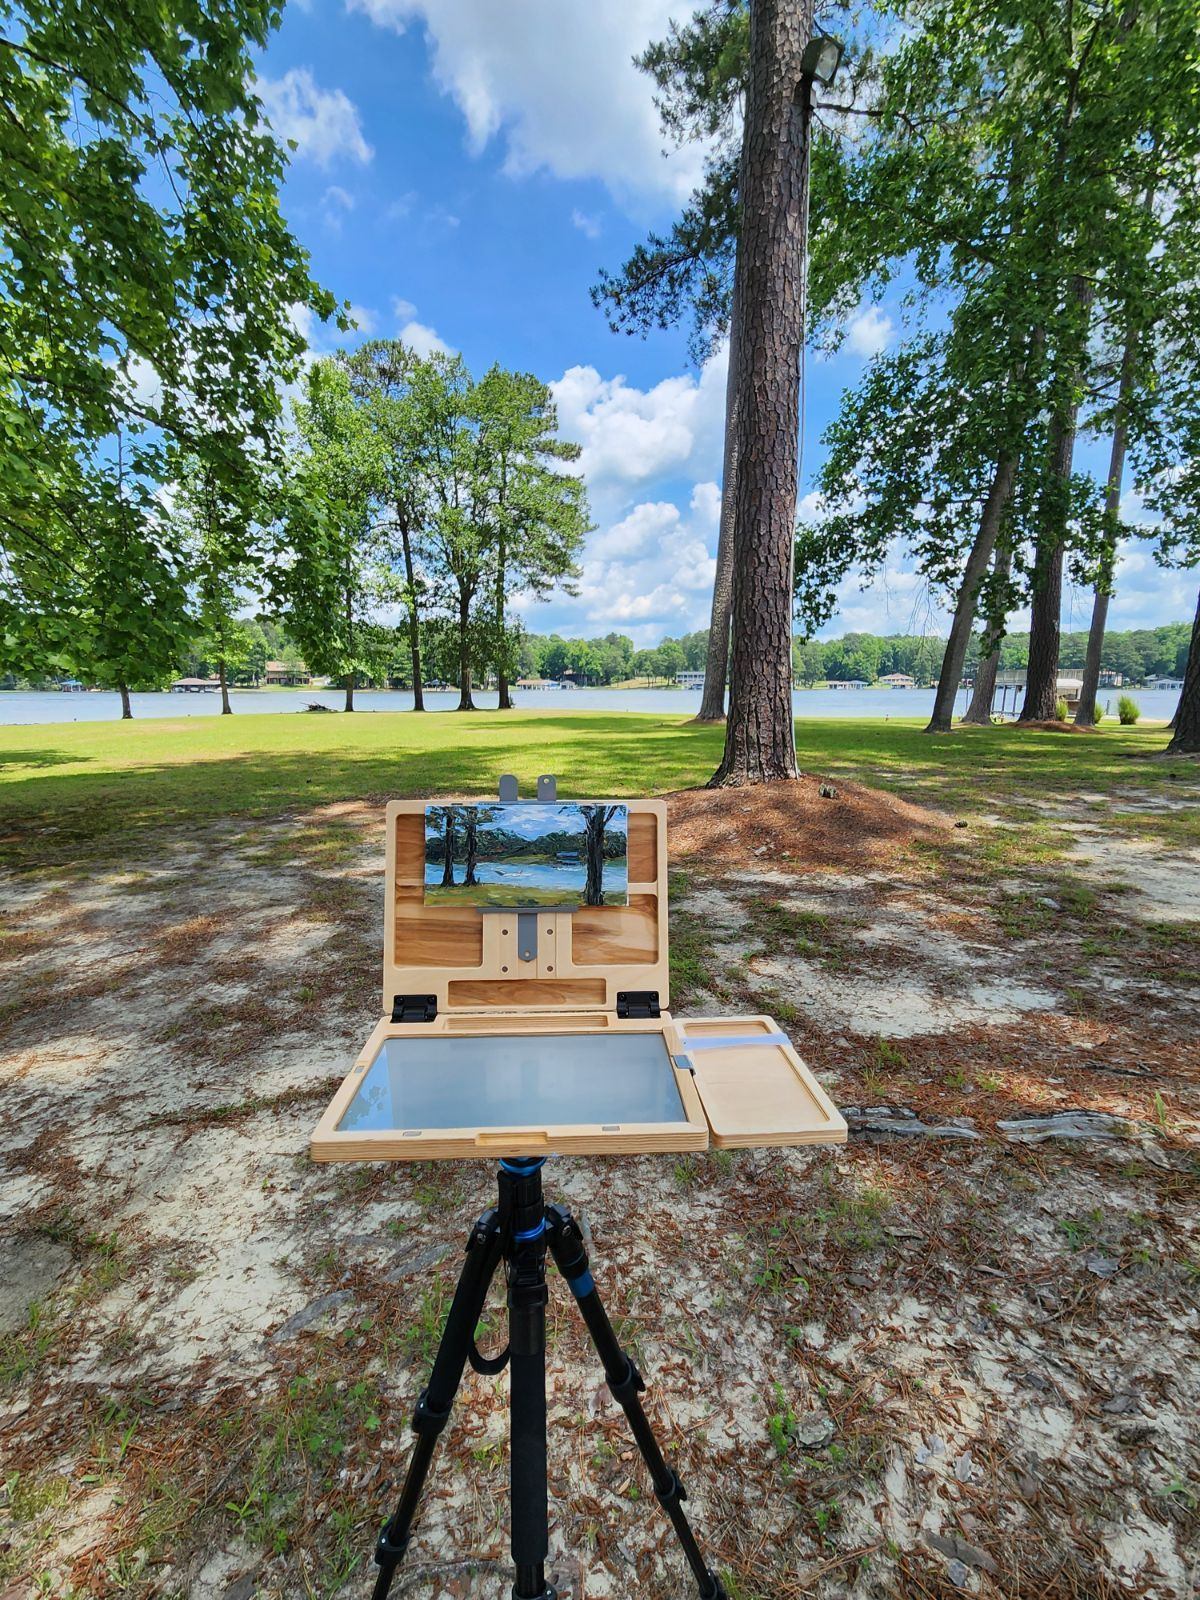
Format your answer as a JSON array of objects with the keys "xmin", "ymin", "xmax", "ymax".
[{"xmin": 0, "ymin": 790, "xmax": 1200, "ymax": 1600}]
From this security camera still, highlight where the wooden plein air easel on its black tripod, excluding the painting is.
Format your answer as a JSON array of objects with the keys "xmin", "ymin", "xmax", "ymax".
[{"xmin": 310, "ymin": 778, "xmax": 846, "ymax": 1600}]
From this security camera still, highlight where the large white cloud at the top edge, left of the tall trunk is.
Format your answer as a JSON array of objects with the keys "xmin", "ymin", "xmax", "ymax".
[{"xmin": 349, "ymin": 0, "xmax": 704, "ymax": 200}]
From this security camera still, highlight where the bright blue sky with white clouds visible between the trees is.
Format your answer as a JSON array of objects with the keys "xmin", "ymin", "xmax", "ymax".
[{"xmin": 251, "ymin": 0, "xmax": 1195, "ymax": 645}]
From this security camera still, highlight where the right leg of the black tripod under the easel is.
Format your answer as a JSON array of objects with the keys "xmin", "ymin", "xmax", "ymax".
[{"xmin": 546, "ymin": 1205, "xmax": 728, "ymax": 1600}]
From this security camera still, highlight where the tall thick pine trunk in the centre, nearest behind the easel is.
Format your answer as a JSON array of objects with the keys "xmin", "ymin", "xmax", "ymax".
[{"xmin": 710, "ymin": 0, "xmax": 813, "ymax": 786}]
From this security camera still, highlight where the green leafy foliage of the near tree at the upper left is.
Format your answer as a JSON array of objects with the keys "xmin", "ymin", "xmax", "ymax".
[{"xmin": 0, "ymin": 0, "xmax": 333, "ymax": 683}]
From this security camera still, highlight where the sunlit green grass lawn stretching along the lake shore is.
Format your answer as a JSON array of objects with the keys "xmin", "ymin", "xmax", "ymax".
[{"xmin": 0, "ymin": 710, "xmax": 1197, "ymax": 864}]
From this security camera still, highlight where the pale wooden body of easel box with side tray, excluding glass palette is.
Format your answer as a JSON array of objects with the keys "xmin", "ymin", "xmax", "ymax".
[{"xmin": 310, "ymin": 800, "xmax": 846, "ymax": 1162}]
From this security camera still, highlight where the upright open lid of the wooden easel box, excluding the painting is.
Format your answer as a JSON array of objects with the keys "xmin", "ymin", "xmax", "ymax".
[{"xmin": 382, "ymin": 782, "xmax": 670, "ymax": 1019}]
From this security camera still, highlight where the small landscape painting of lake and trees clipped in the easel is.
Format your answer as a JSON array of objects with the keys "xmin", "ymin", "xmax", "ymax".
[{"xmin": 426, "ymin": 803, "xmax": 629, "ymax": 909}]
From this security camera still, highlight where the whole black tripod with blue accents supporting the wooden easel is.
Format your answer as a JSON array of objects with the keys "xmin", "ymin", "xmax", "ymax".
[{"xmin": 373, "ymin": 1157, "xmax": 728, "ymax": 1600}]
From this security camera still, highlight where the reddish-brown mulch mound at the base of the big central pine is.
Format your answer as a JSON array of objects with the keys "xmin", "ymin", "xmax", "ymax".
[{"xmin": 667, "ymin": 776, "xmax": 955, "ymax": 870}]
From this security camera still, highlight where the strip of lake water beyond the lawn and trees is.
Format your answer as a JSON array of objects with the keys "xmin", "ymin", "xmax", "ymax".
[{"xmin": 0, "ymin": 690, "xmax": 1179, "ymax": 725}]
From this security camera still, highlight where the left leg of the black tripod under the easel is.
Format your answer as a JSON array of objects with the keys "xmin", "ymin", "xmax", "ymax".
[{"xmin": 373, "ymin": 1210, "xmax": 501, "ymax": 1600}]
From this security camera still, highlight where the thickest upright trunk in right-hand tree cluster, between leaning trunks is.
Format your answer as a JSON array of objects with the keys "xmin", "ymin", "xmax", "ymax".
[{"xmin": 1021, "ymin": 278, "xmax": 1091, "ymax": 722}]
